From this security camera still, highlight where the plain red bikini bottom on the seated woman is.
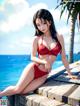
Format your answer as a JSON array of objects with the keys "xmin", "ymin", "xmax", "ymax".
[{"xmin": 34, "ymin": 64, "xmax": 48, "ymax": 79}]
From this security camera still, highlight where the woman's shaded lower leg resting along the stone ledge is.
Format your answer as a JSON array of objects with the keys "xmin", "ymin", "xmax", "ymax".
[{"xmin": 21, "ymin": 75, "xmax": 47, "ymax": 94}]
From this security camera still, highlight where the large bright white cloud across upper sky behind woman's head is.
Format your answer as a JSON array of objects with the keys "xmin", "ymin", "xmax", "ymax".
[{"xmin": 0, "ymin": 0, "xmax": 66, "ymax": 32}]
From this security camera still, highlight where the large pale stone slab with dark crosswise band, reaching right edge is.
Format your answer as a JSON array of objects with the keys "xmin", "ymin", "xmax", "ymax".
[{"xmin": 36, "ymin": 80, "xmax": 80, "ymax": 106}]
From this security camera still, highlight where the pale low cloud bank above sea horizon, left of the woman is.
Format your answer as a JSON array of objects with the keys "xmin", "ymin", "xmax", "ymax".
[{"xmin": 0, "ymin": 36, "xmax": 33, "ymax": 54}]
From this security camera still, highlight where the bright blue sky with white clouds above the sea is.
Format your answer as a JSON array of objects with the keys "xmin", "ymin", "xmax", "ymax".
[{"xmin": 0, "ymin": 0, "xmax": 80, "ymax": 54}]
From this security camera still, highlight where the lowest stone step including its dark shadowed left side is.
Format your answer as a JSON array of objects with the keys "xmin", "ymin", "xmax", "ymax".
[{"xmin": 8, "ymin": 93, "xmax": 71, "ymax": 106}]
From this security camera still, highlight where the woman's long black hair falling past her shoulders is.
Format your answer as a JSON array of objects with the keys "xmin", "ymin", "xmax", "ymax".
[{"xmin": 33, "ymin": 9, "xmax": 58, "ymax": 41}]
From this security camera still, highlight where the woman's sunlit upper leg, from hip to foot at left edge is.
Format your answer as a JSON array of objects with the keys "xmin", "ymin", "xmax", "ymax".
[{"xmin": 0, "ymin": 63, "xmax": 34, "ymax": 97}]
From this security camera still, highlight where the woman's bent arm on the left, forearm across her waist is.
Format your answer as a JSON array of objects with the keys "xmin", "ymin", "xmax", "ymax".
[{"xmin": 31, "ymin": 37, "xmax": 46, "ymax": 65}]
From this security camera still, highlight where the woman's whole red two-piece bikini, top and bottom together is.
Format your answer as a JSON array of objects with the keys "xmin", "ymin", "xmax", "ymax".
[{"xmin": 34, "ymin": 38, "xmax": 61, "ymax": 79}]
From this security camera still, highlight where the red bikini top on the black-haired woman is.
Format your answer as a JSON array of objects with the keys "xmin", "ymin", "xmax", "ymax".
[{"xmin": 37, "ymin": 36, "xmax": 62, "ymax": 56}]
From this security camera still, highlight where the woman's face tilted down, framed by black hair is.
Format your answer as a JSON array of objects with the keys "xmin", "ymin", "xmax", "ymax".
[{"xmin": 36, "ymin": 18, "xmax": 51, "ymax": 34}]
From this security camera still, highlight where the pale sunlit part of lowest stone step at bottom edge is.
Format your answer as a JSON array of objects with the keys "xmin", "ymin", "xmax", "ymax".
[{"xmin": 26, "ymin": 94, "xmax": 70, "ymax": 106}]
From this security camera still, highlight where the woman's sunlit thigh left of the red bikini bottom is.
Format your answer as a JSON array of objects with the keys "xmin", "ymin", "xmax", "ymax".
[{"xmin": 16, "ymin": 63, "xmax": 34, "ymax": 90}]
